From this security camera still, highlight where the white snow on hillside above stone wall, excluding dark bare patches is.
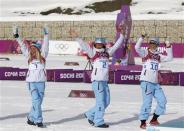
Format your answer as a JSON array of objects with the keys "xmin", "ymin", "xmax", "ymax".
[{"xmin": 0, "ymin": 0, "xmax": 184, "ymax": 21}]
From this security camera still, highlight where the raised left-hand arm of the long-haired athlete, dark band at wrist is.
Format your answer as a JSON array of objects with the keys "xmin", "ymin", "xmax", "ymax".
[{"xmin": 13, "ymin": 27, "xmax": 29, "ymax": 58}]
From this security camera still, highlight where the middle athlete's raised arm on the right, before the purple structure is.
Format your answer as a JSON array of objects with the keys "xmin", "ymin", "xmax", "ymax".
[{"xmin": 108, "ymin": 34, "xmax": 124, "ymax": 56}]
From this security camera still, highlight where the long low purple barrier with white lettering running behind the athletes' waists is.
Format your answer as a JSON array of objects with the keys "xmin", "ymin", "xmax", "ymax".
[{"xmin": 0, "ymin": 67, "xmax": 184, "ymax": 86}]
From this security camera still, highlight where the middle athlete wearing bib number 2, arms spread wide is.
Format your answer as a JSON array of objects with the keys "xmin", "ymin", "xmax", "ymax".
[{"xmin": 77, "ymin": 32, "xmax": 124, "ymax": 128}]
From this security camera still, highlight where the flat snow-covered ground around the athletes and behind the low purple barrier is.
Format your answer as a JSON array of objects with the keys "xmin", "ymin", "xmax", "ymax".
[{"xmin": 0, "ymin": 55, "xmax": 184, "ymax": 131}]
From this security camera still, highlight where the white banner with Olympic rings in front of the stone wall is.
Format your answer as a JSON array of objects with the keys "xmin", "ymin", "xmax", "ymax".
[{"xmin": 49, "ymin": 40, "xmax": 79, "ymax": 55}]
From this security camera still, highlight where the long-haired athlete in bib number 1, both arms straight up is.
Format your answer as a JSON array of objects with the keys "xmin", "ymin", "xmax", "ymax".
[{"xmin": 14, "ymin": 27, "xmax": 49, "ymax": 127}]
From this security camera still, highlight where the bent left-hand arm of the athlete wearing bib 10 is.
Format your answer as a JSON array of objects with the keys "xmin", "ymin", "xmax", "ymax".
[{"xmin": 135, "ymin": 36, "xmax": 145, "ymax": 57}]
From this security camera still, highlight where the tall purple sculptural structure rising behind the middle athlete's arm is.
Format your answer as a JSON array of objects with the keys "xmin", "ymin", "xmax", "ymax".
[{"xmin": 112, "ymin": 5, "xmax": 132, "ymax": 64}]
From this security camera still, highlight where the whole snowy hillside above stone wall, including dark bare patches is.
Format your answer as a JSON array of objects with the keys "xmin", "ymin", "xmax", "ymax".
[{"xmin": 0, "ymin": 0, "xmax": 184, "ymax": 20}]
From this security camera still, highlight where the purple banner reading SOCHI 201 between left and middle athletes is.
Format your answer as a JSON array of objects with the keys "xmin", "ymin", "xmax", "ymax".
[{"xmin": 54, "ymin": 69, "xmax": 84, "ymax": 82}]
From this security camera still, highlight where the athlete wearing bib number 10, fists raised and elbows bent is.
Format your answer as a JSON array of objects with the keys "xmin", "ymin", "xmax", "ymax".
[{"xmin": 135, "ymin": 36, "xmax": 173, "ymax": 129}]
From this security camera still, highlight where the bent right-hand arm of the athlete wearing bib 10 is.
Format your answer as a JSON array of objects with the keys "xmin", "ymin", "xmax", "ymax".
[{"xmin": 160, "ymin": 41, "xmax": 173, "ymax": 62}]
